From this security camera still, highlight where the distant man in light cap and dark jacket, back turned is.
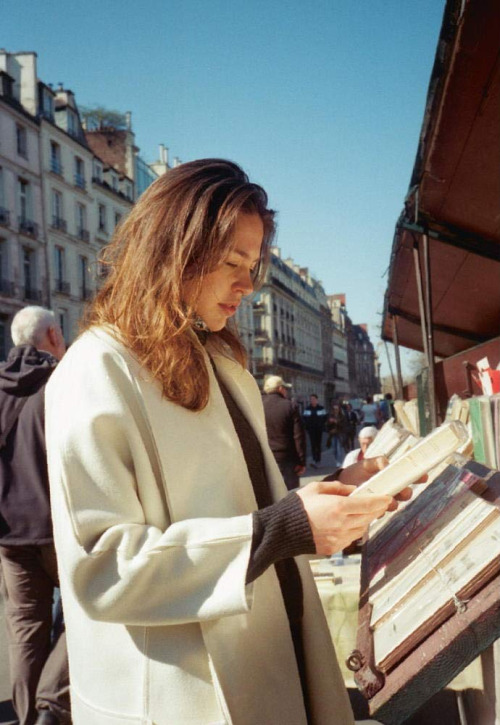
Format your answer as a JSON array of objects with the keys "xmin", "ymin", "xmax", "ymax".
[{"xmin": 262, "ymin": 375, "xmax": 306, "ymax": 491}]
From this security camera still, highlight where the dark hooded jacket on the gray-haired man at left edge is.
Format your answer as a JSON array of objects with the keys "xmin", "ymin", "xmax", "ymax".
[{"xmin": 0, "ymin": 345, "xmax": 57, "ymax": 546}]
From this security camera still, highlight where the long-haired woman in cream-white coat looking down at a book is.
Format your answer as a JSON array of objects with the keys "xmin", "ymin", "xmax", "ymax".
[{"xmin": 47, "ymin": 160, "xmax": 391, "ymax": 725}]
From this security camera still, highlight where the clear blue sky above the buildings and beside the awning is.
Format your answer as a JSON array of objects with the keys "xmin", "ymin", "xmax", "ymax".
[{"xmin": 0, "ymin": 0, "xmax": 445, "ymax": 374}]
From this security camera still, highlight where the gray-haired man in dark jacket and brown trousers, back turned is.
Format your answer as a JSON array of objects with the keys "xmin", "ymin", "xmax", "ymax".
[{"xmin": 0, "ymin": 307, "xmax": 71, "ymax": 725}]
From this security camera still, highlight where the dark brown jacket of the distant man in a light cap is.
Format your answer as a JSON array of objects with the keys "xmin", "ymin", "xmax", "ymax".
[{"xmin": 263, "ymin": 393, "xmax": 306, "ymax": 466}]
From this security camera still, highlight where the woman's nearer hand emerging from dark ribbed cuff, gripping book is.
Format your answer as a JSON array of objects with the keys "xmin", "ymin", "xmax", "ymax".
[{"xmin": 297, "ymin": 480, "xmax": 394, "ymax": 555}]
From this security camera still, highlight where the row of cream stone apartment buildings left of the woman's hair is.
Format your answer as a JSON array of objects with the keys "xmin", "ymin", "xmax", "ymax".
[{"xmin": 0, "ymin": 51, "xmax": 134, "ymax": 350}]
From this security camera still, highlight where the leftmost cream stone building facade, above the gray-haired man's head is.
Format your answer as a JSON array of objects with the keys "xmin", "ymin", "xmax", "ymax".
[{"xmin": 0, "ymin": 51, "xmax": 49, "ymax": 360}]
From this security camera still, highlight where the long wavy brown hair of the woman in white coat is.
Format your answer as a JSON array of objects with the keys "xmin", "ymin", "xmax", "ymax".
[{"xmin": 83, "ymin": 159, "xmax": 275, "ymax": 410}]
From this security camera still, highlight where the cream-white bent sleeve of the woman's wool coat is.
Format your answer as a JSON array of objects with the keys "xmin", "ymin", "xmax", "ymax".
[{"xmin": 46, "ymin": 343, "xmax": 252, "ymax": 625}]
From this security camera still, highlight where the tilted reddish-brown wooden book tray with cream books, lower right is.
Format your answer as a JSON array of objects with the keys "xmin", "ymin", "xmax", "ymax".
[{"xmin": 347, "ymin": 429, "xmax": 500, "ymax": 725}]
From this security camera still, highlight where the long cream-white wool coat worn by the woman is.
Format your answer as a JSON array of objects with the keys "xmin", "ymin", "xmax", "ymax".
[{"xmin": 46, "ymin": 329, "xmax": 353, "ymax": 725}]
